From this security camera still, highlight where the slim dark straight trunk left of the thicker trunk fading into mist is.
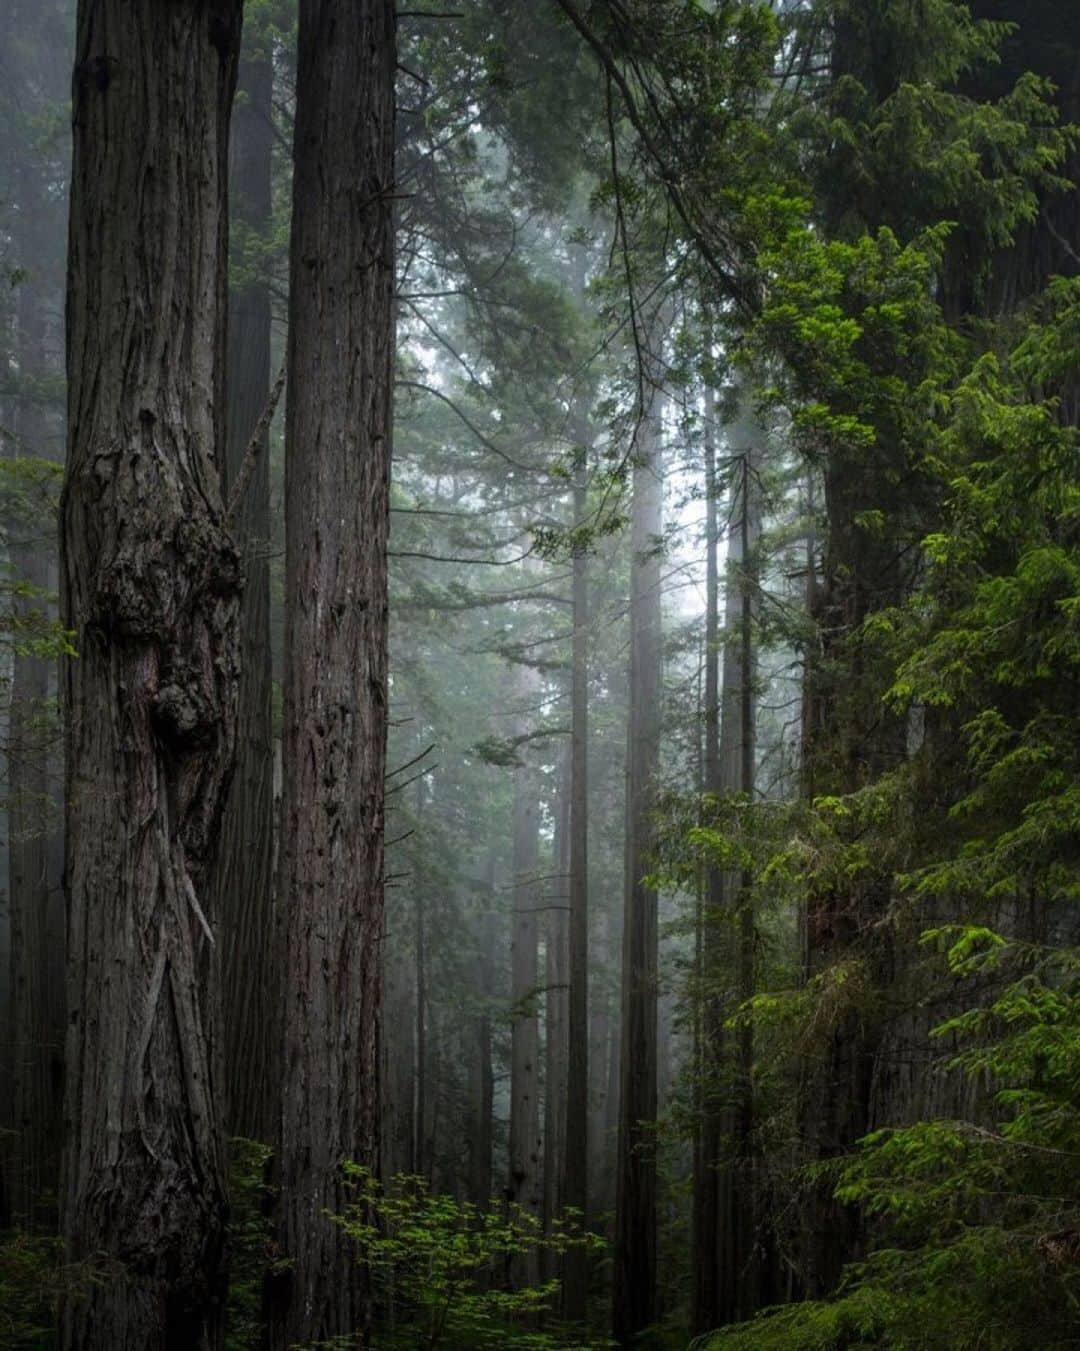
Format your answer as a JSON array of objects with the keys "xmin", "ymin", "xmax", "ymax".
[{"xmin": 562, "ymin": 453, "xmax": 589, "ymax": 1323}]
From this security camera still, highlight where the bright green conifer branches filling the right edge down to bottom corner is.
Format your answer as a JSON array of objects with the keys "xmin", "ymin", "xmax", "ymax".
[{"xmin": 711, "ymin": 179, "xmax": 1080, "ymax": 1351}]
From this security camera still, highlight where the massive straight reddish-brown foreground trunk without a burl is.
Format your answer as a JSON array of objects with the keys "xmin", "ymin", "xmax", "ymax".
[{"xmin": 270, "ymin": 0, "xmax": 396, "ymax": 1347}]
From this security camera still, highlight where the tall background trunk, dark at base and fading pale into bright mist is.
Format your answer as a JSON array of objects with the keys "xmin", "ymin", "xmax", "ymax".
[{"xmin": 614, "ymin": 375, "xmax": 662, "ymax": 1346}]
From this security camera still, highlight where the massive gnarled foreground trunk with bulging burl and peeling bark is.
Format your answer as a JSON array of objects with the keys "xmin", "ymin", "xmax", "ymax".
[{"xmin": 61, "ymin": 0, "xmax": 241, "ymax": 1351}]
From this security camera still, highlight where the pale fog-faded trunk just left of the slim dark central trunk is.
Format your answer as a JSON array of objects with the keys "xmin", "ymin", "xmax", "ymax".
[{"xmin": 507, "ymin": 666, "xmax": 542, "ymax": 1285}]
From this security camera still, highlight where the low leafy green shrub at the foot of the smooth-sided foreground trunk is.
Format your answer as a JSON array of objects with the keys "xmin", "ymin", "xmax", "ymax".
[{"xmin": 335, "ymin": 1165, "xmax": 602, "ymax": 1351}]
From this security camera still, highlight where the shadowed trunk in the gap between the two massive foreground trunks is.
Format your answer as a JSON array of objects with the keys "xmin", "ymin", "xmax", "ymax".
[{"xmin": 214, "ymin": 47, "xmax": 281, "ymax": 1140}]
